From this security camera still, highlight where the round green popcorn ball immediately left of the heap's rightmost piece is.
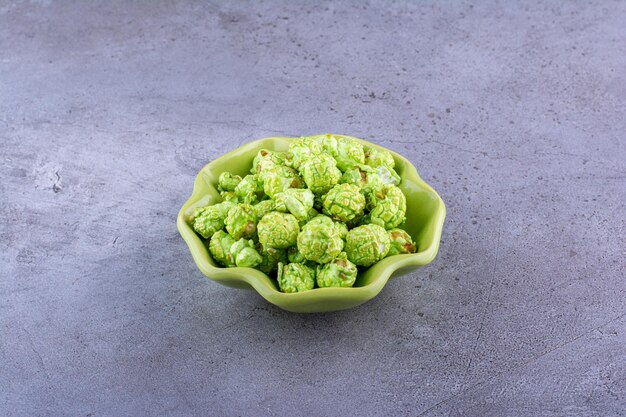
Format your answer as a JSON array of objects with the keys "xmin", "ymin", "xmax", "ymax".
[{"xmin": 346, "ymin": 224, "xmax": 391, "ymax": 266}]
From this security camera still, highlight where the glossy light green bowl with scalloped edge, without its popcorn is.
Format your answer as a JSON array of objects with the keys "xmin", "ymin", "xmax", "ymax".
[{"xmin": 176, "ymin": 135, "xmax": 446, "ymax": 313}]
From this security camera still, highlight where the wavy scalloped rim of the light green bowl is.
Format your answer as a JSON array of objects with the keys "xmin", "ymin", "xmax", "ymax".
[{"xmin": 176, "ymin": 134, "xmax": 446, "ymax": 304}]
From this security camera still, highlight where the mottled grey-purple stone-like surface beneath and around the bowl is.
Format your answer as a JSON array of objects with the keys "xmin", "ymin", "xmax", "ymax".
[{"xmin": 0, "ymin": 1, "xmax": 626, "ymax": 416}]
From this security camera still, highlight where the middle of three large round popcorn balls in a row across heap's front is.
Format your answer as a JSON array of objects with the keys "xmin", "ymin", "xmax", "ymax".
[{"xmin": 298, "ymin": 215, "xmax": 343, "ymax": 264}]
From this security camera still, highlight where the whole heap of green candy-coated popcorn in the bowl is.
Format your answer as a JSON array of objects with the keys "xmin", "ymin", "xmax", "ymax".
[{"xmin": 192, "ymin": 135, "xmax": 416, "ymax": 292}]
